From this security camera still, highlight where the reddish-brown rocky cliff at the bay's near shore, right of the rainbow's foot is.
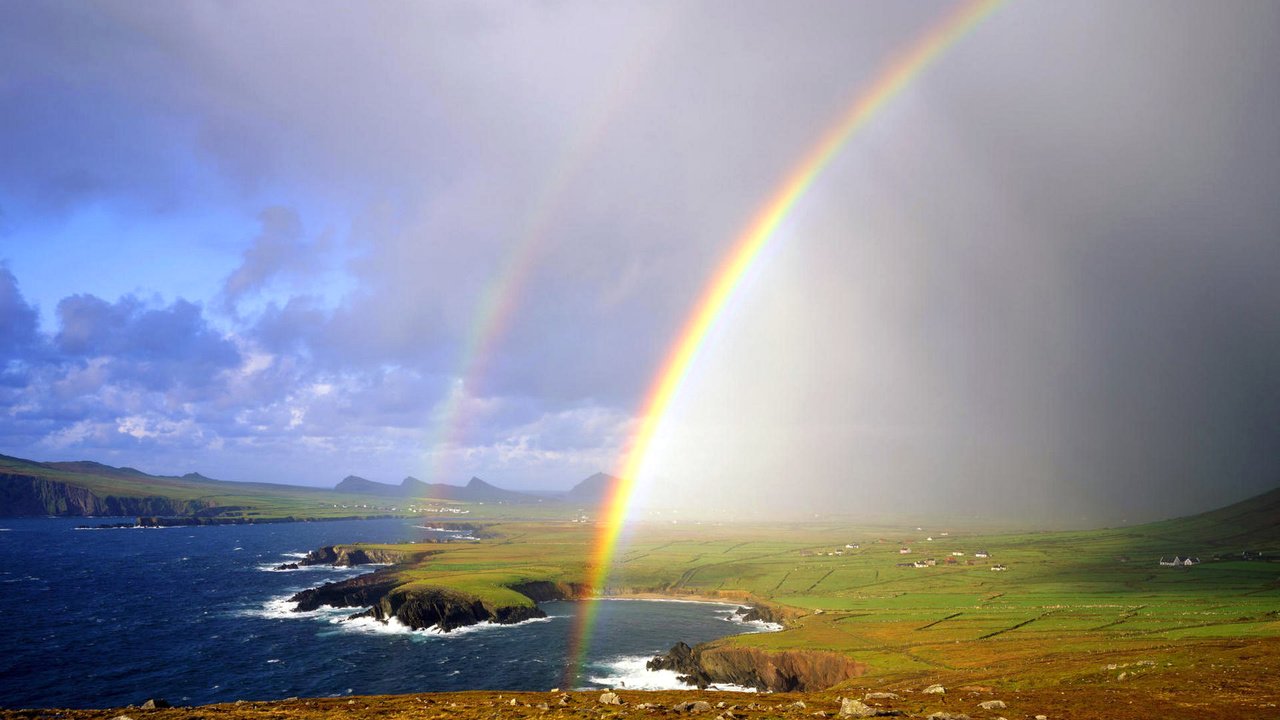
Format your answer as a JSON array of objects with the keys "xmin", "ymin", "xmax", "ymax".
[{"xmin": 648, "ymin": 643, "xmax": 867, "ymax": 692}]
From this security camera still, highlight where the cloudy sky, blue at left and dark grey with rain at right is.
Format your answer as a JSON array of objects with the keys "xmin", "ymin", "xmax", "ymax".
[{"xmin": 0, "ymin": 0, "xmax": 1280, "ymax": 524}]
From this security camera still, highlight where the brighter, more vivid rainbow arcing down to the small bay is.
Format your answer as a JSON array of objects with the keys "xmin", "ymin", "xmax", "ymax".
[{"xmin": 564, "ymin": 0, "xmax": 1002, "ymax": 687}]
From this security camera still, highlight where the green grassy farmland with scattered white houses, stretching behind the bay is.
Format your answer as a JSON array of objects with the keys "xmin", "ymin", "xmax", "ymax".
[{"xmin": 294, "ymin": 481, "xmax": 1280, "ymax": 687}]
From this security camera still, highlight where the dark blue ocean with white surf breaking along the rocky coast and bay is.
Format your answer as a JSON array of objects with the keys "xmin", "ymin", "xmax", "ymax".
[{"xmin": 0, "ymin": 518, "xmax": 763, "ymax": 707}]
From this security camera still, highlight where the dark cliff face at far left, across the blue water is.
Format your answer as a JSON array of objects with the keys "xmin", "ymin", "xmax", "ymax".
[{"xmin": 0, "ymin": 473, "xmax": 209, "ymax": 518}]
